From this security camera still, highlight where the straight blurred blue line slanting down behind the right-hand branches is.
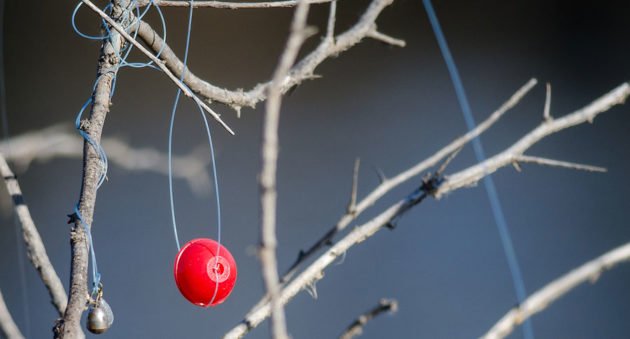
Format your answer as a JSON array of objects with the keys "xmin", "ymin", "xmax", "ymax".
[{"xmin": 422, "ymin": 0, "xmax": 534, "ymax": 339}]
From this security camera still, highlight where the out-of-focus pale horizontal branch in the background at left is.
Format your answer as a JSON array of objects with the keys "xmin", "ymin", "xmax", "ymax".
[{"xmin": 0, "ymin": 124, "xmax": 211, "ymax": 195}]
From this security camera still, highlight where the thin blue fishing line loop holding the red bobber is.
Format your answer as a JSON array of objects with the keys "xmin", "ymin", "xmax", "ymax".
[{"xmin": 168, "ymin": 0, "xmax": 226, "ymax": 305}]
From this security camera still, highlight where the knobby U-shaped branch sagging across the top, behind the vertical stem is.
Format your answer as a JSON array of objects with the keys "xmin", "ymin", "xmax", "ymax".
[{"xmin": 138, "ymin": 0, "xmax": 402, "ymax": 112}]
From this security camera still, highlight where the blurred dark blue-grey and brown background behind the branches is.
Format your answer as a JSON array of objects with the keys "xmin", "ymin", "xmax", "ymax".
[{"xmin": 0, "ymin": 0, "xmax": 630, "ymax": 338}]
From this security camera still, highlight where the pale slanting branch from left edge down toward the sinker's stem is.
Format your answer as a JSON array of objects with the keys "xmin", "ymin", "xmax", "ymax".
[{"xmin": 0, "ymin": 154, "xmax": 68, "ymax": 316}]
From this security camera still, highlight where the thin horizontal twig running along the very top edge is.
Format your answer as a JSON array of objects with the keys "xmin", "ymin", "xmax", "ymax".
[{"xmin": 138, "ymin": 0, "xmax": 332, "ymax": 9}]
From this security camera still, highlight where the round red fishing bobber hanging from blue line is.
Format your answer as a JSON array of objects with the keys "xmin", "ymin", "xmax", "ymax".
[{"xmin": 174, "ymin": 238, "xmax": 237, "ymax": 307}]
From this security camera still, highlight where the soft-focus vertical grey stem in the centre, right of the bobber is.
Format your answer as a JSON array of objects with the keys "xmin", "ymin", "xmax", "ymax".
[{"xmin": 260, "ymin": 1, "xmax": 310, "ymax": 339}]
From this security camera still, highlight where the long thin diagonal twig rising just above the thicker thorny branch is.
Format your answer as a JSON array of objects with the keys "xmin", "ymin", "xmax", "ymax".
[{"xmin": 282, "ymin": 79, "xmax": 536, "ymax": 282}]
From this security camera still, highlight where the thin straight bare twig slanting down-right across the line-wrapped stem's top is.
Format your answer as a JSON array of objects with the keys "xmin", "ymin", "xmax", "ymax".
[{"xmin": 81, "ymin": 0, "xmax": 234, "ymax": 135}]
